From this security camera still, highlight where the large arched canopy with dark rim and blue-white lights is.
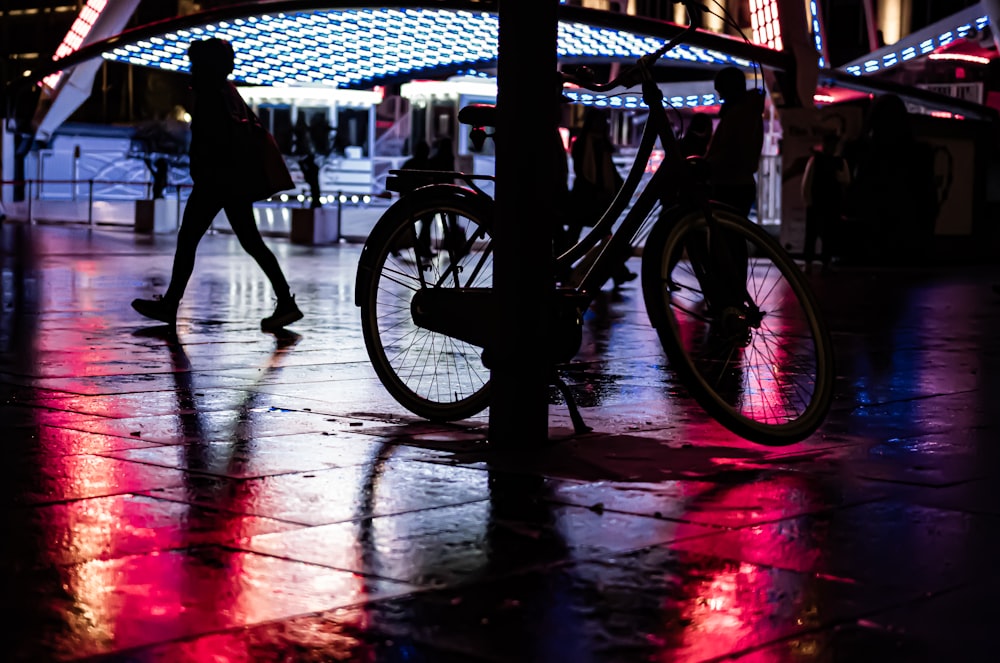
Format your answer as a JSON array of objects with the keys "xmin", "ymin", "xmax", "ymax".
[{"xmin": 39, "ymin": 1, "xmax": 784, "ymax": 89}]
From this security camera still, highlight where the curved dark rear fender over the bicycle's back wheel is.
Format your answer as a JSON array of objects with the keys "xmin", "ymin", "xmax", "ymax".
[{"xmin": 354, "ymin": 184, "xmax": 493, "ymax": 306}]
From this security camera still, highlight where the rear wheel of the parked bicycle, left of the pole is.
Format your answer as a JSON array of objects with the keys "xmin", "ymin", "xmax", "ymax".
[{"xmin": 357, "ymin": 192, "xmax": 493, "ymax": 421}]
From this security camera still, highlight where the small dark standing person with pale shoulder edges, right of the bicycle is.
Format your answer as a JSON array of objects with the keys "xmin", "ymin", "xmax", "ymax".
[{"xmin": 802, "ymin": 131, "xmax": 851, "ymax": 272}]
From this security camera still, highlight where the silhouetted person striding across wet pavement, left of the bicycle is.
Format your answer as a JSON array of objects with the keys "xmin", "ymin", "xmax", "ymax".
[{"xmin": 132, "ymin": 38, "xmax": 302, "ymax": 331}]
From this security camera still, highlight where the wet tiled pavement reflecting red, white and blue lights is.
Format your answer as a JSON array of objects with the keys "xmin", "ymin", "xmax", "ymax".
[{"xmin": 0, "ymin": 224, "xmax": 1000, "ymax": 663}]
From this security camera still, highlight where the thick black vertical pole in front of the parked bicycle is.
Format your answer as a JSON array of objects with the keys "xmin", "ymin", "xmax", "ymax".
[{"xmin": 490, "ymin": 0, "xmax": 559, "ymax": 445}]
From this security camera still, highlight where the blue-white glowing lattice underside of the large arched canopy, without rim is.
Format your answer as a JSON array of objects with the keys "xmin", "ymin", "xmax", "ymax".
[{"xmin": 103, "ymin": 9, "xmax": 750, "ymax": 88}]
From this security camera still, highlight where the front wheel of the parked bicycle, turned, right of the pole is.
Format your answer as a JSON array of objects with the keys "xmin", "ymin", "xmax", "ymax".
[{"xmin": 642, "ymin": 207, "xmax": 834, "ymax": 445}]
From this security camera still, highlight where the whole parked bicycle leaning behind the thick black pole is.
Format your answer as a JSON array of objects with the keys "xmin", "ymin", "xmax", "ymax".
[{"xmin": 356, "ymin": 2, "xmax": 834, "ymax": 445}]
